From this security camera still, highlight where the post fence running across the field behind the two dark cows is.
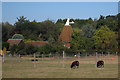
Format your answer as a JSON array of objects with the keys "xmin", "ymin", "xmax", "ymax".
[{"xmin": 2, "ymin": 51, "xmax": 118, "ymax": 68}]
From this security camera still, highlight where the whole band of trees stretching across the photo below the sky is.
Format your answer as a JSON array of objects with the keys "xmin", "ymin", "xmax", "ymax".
[{"xmin": 2, "ymin": 14, "xmax": 120, "ymax": 54}]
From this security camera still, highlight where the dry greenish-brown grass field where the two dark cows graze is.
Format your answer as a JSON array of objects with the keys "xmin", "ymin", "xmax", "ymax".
[{"xmin": 2, "ymin": 56, "xmax": 118, "ymax": 78}]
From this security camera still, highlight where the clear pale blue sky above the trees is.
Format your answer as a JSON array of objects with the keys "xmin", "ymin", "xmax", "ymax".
[{"xmin": 2, "ymin": 2, "xmax": 118, "ymax": 24}]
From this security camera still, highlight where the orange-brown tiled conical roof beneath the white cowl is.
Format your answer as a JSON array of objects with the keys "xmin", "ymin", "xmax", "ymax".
[{"xmin": 59, "ymin": 25, "xmax": 73, "ymax": 43}]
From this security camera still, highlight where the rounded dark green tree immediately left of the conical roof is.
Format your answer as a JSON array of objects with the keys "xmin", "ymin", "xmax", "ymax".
[{"xmin": 39, "ymin": 20, "xmax": 59, "ymax": 41}]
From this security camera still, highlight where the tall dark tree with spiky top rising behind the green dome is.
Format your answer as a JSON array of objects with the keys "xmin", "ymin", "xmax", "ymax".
[{"xmin": 14, "ymin": 16, "xmax": 39, "ymax": 40}]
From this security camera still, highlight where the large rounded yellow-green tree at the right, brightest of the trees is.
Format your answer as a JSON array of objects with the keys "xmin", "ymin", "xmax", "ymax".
[{"xmin": 93, "ymin": 26, "xmax": 117, "ymax": 51}]
